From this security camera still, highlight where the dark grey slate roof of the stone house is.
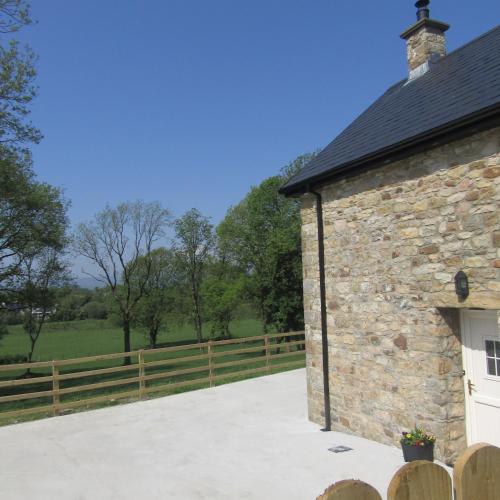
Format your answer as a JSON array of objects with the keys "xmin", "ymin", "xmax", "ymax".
[{"xmin": 281, "ymin": 26, "xmax": 500, "ymax": 194}]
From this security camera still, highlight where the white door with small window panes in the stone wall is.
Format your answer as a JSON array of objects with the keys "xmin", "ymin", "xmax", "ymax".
[{"xmin": 462, "ymin": 310, "xmax": 500, "ymax": 446}]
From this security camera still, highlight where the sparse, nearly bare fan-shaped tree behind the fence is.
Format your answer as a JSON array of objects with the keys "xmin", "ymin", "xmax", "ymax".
[{"xmin": 74, "ymin": 201, "xmax": 170, "ymax": 364}]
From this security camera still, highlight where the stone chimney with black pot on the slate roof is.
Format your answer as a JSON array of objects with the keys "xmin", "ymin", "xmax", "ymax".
[{"xmin": 401, "ymin": 0, "xmax": 450, "ymax": 80}]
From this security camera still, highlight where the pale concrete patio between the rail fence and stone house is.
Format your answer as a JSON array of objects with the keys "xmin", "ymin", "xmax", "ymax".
[{"xmin": 0, "ymin": 370, "xmax": 410, "ymax": 500}]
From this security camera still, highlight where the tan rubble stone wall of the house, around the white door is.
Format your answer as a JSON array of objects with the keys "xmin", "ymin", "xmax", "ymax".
[{"xmin": 302, "ymin": 128, "xmax": 500, "ymax": 462}]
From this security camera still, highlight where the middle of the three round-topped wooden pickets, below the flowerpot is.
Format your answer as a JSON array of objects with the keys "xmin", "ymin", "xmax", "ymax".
[{"xmin": 387, "ymin": 460, "xmax": 454, "ymax": 500}]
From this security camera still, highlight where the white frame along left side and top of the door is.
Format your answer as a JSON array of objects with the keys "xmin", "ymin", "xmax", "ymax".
[{"xmin": 460, "ymin": 308, "xmax": 498, "ymax": 446}]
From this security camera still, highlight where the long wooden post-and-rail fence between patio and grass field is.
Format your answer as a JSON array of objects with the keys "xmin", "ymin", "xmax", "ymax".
[{"xmin": 0, "ymin": 332, "xmax": 305, "ymax": 420}]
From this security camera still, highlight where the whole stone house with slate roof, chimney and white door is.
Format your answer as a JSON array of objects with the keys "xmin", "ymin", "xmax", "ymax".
[{"xmin": 282, "ymin": 0, "xmax": 500, "ymax": 463}]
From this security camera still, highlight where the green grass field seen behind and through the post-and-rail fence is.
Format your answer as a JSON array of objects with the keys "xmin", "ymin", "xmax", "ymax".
[{"xmin": 0, "ymin": 319, "xmax": 305, "ymax": 425}]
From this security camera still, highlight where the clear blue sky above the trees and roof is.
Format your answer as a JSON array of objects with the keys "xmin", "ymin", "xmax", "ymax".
[{"xmin": 15, "ymin": 0, "xmax": 500, "ymax": 262}]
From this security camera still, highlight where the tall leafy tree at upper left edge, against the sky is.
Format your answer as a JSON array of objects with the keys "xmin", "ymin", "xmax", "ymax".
[{"xmin": 0, "ymin": 0, "xmax": 67, "ymax": 291}]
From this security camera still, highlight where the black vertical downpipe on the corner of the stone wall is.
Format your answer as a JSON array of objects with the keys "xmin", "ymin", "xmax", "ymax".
[{"xmin": 308, "ymin": 187, "xmax": 332, "ymax": 431}]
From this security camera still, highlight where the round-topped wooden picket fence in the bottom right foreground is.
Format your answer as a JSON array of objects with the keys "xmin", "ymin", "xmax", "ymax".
[{"xmin": 317, "ymin": 443, "xmax": 500, "ymax": 500}]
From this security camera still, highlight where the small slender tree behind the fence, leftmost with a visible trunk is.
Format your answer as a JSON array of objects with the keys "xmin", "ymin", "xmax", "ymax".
[{"xmin": 15, "ymin": 249, "xmax": 69, "ymax": 373}]
